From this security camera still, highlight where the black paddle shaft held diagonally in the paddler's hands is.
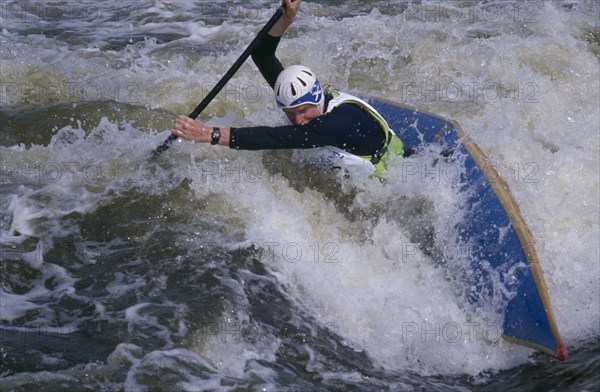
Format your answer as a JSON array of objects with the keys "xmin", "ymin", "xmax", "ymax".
[{"xmin": 152, "ymin": 6, "xmax": 285, "ymax": 158}]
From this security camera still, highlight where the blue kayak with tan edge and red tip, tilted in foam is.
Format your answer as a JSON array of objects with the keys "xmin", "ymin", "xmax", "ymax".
[{"xmin": 367, "ymin": 99, "xmax": 567, "ymax": 360}]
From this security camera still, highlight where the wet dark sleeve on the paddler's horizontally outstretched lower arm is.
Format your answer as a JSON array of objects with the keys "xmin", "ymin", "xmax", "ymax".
[{"xmin": 229, "ymin": 104, "xmax": 385, "ymax": 155}]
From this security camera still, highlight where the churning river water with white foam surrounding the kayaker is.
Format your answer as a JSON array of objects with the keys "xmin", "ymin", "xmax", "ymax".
[{"xmin": 0, "ymin": 0, "xmax": 600, "ymax": 391}]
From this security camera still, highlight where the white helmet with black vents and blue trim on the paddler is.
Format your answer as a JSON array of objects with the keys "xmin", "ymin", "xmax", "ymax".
[{"xmin": 273, "ymin": 65, "xmax": 323, "ymax": 109}]
